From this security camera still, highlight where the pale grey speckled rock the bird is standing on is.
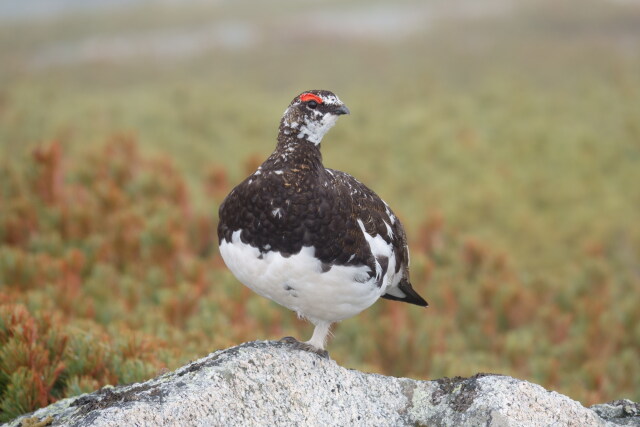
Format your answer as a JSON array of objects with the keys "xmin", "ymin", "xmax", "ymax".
[{"xmin": 8, "ymin": 341, "xmax": 640, "ymax": 427}]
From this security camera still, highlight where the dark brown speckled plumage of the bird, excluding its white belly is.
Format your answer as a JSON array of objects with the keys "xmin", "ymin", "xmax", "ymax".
[{"xmin": 218, "ymin": 91, "xmax": 427, "ymax": 306}]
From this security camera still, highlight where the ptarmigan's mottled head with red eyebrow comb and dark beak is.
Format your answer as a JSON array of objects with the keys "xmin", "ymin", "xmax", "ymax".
[{"xmin": 280, "ymin": 90, "xmax": 349, "ymax": 145}]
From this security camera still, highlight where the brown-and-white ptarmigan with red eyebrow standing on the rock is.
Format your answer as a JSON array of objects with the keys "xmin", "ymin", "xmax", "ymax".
[{"xmin": 217, "ymin": 90, "xmax": 428, "ymax": 357}]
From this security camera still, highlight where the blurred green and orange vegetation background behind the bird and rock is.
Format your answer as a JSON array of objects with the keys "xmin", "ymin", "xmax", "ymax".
[{"xmin": 0, "ymin": 0, "xmax": 640, "ymax": 421}]
